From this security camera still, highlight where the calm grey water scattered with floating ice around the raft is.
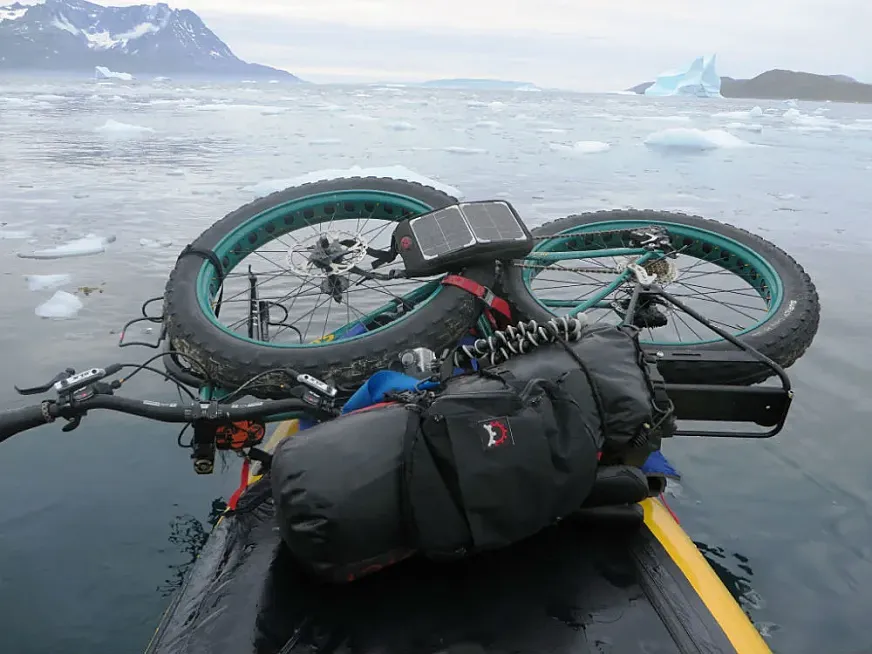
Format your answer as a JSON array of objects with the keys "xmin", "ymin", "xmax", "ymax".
[{"xmin": 0, "ymin": 80, "xmax": 872, "ymax": 654}]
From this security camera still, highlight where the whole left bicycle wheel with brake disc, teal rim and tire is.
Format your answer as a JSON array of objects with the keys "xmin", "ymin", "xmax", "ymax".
[{"xmin": 164, "ymin": 177, "xmax": 495, "ymax": 397}]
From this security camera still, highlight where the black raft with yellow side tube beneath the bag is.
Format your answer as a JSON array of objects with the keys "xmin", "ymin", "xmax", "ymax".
[{"xmin": 146, "ymin": 423, "xmax": 770, "ymax": 654}]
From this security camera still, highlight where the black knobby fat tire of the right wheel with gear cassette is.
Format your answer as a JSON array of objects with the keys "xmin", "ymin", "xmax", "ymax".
[{"xmin": 500, "ymin": 209, "xmax": 820, "ymax": 385}]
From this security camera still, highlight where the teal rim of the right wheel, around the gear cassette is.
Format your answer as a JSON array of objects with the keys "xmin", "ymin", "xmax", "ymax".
[{"xmin": 523, "ymin": 220, "xmax": 784, "ymax": 346}]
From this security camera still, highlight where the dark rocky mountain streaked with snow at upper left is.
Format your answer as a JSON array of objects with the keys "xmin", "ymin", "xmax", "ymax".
[{"xmin": 0, "ymin": 0, "xmax": 297, "ymax": 81}]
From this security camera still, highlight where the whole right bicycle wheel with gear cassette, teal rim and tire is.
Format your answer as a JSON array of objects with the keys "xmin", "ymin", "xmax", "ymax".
[{"xmin": 502, "ymin": 210, "xmax": 820, "ymax": 384}]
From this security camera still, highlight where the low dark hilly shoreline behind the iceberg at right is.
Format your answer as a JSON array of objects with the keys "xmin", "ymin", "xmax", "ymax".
[{"xmin": 627, "ymin": 69, "xmax": 872, "ymax": 103}]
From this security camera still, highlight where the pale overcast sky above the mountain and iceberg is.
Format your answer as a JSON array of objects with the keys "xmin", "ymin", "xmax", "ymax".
[{"xmin": 54, "ymin": 0, "xmax": 872, "ymax": 90}]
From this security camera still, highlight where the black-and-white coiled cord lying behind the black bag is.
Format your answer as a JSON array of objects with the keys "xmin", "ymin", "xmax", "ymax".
[{"xmin": 453, "ymin": 313, "xmax": 587, "ymax": 368}]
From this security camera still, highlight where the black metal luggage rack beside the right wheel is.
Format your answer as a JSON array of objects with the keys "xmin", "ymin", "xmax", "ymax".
[{"xmin": 623, "ymin": 274, "xmax": 793, "ymax": 438}]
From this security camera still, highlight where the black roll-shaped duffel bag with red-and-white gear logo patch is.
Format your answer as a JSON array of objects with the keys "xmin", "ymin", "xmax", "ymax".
[{"xmin": 270, "ymin": 326, "xmax": 659, "ymax": 581}]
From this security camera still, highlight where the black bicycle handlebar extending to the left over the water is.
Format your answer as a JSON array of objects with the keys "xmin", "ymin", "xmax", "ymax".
[{"xmin": 0, "ymin": 394, "xmax": 323, "ymax": 442}]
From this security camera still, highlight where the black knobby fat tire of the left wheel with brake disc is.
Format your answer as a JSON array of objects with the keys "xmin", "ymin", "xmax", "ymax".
[{"xmin": 164, "ymin": 177, "xmax": 496, "ymax": 398}]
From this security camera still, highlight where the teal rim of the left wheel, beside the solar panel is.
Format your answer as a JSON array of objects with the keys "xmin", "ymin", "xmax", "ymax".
[{"xmin": 196, "ymin": 190, "xmax": 442, "ymax": 349}]
